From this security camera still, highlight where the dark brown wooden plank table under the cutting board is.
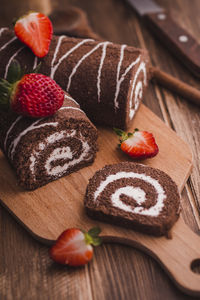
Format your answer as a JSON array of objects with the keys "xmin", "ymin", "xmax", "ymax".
[{"xmin": 0, "ymin": 0, "xmax": 200, "ymax": 300}]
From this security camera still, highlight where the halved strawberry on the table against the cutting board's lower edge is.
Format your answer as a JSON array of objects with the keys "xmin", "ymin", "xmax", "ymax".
[{"xmin": 49, "ymin": 228, "xmax": 101, "ymax": 266}]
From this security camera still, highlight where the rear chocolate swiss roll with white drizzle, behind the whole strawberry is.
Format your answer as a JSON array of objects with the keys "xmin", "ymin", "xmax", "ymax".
[{"xmin": 0, "ymin": 28, "xmax": 150, "ymax": 129}]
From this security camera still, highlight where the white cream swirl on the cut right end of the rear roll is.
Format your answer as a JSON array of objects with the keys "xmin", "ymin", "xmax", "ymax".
[{"xmin": 129, "ymin": 61, "xmax": 147, "ymax": 120}]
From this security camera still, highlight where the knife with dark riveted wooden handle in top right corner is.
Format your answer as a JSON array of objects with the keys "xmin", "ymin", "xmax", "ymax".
[{"xmin": 128, "ymin": 0, "xmax": 200, "ymax": 77}]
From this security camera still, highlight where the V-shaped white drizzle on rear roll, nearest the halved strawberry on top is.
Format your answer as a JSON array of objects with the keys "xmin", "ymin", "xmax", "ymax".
[{"xmin": 50, "ymin": 36, "xmax": 93, "ymax": 79}]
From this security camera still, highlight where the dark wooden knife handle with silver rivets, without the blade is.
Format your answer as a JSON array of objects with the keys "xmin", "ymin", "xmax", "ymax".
[{"xmin": 145, "ymin": 12, "xmax": 200, "ymax": 77}]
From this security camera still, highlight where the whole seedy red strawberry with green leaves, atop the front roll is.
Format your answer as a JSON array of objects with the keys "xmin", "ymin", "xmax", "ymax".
[{"xmin": 0, "ymin": 61, "xmax": 64, "ymax": 118}]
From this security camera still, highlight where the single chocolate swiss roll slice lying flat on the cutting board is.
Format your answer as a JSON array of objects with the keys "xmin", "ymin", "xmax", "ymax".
[{"xmin": 84, "ymin": 162, "xmax": 180, "ymax": 236}]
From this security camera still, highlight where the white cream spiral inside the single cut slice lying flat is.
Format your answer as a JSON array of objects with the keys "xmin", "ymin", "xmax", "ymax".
[{"xmin": 94, "ymin": 171, "xmax": 166, "ymax": 217}]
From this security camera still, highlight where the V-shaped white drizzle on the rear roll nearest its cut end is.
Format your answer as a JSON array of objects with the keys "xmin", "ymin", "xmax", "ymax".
[{"xmin": 114, "ymin": 51, "xmax": 140, "ymax": 108}]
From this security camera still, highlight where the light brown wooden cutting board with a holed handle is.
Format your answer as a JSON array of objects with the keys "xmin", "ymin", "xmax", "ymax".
[{"xmin": 0, "ymin": 105, "xmax": 200, "ymax": 295}]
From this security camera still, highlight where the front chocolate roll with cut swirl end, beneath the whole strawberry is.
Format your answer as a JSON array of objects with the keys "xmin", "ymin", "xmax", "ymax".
[{"xmin": 0, "ymin": 93, "xmax": 97, "ymax": 190}]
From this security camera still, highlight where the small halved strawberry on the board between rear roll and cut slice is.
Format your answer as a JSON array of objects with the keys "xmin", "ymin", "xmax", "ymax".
[{"xmin": 114, "ymin": 128, "xmax": 158, "ymax": 159}]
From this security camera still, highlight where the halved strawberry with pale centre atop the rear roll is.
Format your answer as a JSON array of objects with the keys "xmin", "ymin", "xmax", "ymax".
[{"xmin": 14, "ymin": 12, "xmax": 53, "ymax": 57}]
